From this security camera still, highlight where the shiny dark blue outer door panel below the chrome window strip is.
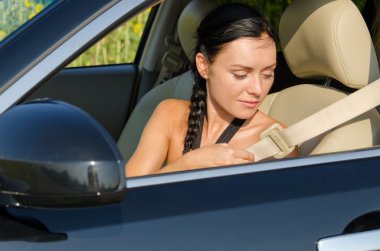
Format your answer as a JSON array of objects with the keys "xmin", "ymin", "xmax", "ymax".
[{"xmin": 0, "ymin": 157, "xmax": 380, "ymax": 251}]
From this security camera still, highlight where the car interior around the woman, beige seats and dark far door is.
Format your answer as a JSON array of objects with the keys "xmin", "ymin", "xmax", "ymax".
[{"xmin": 21, "ymin": 0, "xmax": 380, "ymax": 172}]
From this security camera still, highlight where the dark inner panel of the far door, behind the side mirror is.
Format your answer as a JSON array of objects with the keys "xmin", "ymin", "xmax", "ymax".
[{"xmin": 27, "ymin": 64, "xmax": 137, "ymax": 140}]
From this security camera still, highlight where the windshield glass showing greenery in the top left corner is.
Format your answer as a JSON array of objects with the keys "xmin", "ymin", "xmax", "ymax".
[{"xmin": 0, "ymin": 0, "xmax": 58, "ymax": 44}]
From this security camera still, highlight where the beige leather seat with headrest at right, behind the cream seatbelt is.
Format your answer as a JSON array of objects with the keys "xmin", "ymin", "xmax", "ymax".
[{"xmin": 260, "ymin": 0, "xmax": 380, "ymax": 155}]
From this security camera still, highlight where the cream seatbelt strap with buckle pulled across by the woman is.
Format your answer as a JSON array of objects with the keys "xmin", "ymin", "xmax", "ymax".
[{"xmin": 246, "ymin": 79, "xmax": 380, "ymax": 161}]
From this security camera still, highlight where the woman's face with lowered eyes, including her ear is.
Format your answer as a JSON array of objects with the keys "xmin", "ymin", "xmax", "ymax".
[{"xmin": 196, "ymin": 34, "xmax": 276, "ymax": 119}]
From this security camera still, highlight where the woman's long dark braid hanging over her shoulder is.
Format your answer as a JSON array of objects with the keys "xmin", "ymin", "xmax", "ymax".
[{"xmin": 183, "ymin": 69, "xmax": 207, "ymax": 153}]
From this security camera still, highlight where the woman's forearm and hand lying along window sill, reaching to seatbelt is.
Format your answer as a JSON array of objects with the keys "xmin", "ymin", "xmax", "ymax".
[{"xmin": 160, "ymin": 143, "xmax": 255, "ymax": 173}]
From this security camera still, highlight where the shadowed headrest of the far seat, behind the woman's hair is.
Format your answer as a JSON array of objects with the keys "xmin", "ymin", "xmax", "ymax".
[{"xmin": 178, "ymin": 0, "xmax": 219, "ymax": 61}]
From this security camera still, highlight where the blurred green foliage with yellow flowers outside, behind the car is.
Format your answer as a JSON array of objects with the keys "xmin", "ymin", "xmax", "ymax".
[{"xmin": 0, "ymin": 0, "xmax": 366, "ymax": 67}]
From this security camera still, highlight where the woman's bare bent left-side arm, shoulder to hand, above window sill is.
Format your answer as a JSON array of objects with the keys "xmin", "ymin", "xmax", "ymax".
[{"xmin": 125, "ymin": 100, "xmax": 254, "ymax": 177}]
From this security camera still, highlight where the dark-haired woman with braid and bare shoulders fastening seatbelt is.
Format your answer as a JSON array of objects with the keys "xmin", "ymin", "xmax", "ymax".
[{"xmin": 126, "ymin": 4, "xmax": 296, "ymax": 177}]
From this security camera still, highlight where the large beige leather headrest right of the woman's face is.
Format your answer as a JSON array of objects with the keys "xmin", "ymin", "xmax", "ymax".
[{"xmin": 279, "ymin": 0, "xmax": 379, "ymax": 89}]
